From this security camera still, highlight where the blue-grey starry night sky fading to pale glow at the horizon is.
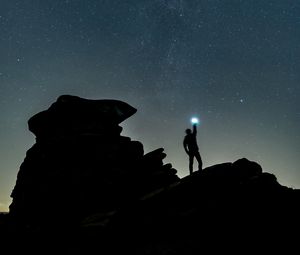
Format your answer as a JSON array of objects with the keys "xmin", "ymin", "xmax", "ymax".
[{"xmin": 0, "ymin": 0, "xmax": 300, "ymax": 211}]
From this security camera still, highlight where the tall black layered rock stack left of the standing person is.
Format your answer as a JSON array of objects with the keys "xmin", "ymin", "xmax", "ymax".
[{"xmin": 10, "ymin": 95, "xmax": 179, "ymax": 227}]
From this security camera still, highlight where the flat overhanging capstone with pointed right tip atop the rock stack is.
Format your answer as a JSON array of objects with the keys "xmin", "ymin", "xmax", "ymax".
[{"xmin": 28, "ymin": 95, "xmax": 136, "ymax": 140}]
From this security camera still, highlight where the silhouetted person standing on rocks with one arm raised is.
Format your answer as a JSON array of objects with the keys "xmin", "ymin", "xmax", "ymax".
[{"xmin": 183, "ymin": 124, "xmax": 202, "ymax": 174}]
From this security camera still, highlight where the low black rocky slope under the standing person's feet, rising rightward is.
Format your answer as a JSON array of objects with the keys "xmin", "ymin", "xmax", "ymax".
[{"xmin": 101, "ymin": 158, "xmax": 300, "ymax": 255}]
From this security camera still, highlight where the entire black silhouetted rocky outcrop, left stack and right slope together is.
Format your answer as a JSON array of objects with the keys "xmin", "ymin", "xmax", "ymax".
[{"xmin": 5, "ymin": 96, "xmax": 300, "ymax": 255}]
